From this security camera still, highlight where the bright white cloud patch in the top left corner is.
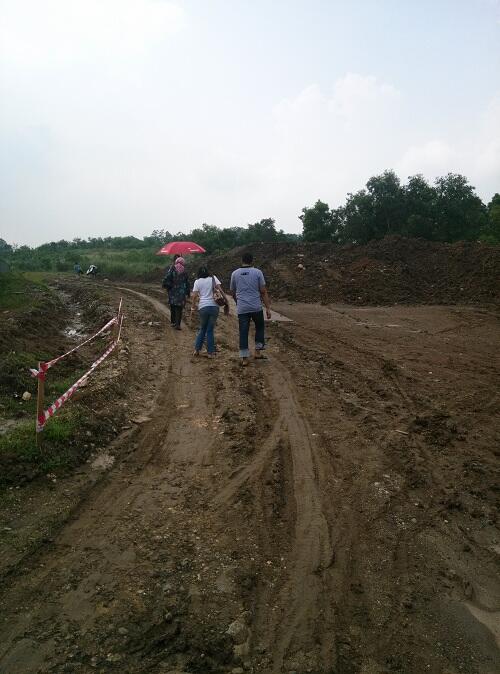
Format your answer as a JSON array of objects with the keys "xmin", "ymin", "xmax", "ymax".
[{"xmin": 0, "ymin": 0, "xmax": 185, "ymax": 69}]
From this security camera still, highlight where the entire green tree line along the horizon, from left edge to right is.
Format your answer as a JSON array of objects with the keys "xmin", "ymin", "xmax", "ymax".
[{"xmin": 0, "ymin": 171, "xmax": 500, "ymax": 274}]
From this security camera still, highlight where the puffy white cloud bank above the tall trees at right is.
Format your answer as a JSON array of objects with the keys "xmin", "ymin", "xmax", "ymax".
[{"xmin": 263, "ymin": 73, "xmax": 500, "ymax": 220}]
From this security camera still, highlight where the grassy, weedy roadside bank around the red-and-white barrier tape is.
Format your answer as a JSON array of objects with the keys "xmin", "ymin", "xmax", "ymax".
[{"xmin": 0, "ymin": 272, "xmax": 114, "ymax": 487}]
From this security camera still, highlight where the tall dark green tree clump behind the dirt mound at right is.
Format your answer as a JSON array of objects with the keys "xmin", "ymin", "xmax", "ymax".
[{"xmin": 299, "ymin": 171, "xmax": 500, "ymax": 244}]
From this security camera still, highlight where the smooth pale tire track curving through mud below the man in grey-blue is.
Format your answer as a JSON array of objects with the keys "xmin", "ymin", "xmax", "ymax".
[{"xmin": 215, "ymin": 338, "xmax": 334, "ymax": 674}]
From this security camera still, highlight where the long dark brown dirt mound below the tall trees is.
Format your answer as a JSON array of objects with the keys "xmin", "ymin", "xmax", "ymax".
[{"xmin": 208, "ymin": 237, "xmax": 500, "ymax": 305}]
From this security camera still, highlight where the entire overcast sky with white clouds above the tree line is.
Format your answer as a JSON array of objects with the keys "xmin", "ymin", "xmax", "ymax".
[{"xmin": 0, "ymin": 0, "xmax": 500, "ymax": 245}]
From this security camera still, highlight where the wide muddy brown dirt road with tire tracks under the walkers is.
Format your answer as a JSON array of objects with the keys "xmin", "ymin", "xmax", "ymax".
[{"xmin": 0, "ymin": 286, "xmax": 500, "ymax": 674}]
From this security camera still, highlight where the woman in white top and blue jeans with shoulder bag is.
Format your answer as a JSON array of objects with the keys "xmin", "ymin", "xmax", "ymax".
[{"xmin": 191, "ymin": 267, "xmax": 229, "ymax": 358}]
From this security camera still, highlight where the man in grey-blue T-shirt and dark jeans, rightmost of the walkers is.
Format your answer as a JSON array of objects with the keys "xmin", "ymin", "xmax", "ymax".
[{"xmin": 231, "ymin": 253, "xmax": 271, "ymax": 366}]
